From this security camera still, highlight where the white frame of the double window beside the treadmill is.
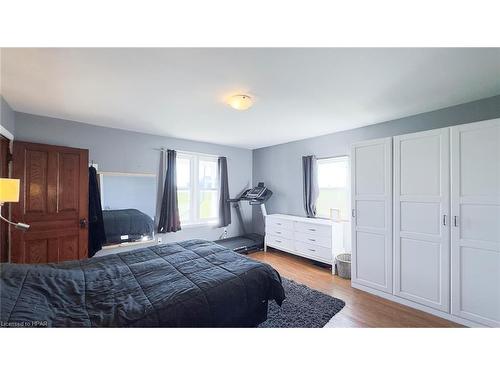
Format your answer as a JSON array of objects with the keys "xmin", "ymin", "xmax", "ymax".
[{"xmin": 176, "ymin": 151, "xmax": 220, "ymax": 227}]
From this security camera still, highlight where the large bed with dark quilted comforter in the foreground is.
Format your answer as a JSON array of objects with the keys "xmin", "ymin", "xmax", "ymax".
[{"xmin": 0, "ymin": 240, "xmax": 285, "ymax": 327}]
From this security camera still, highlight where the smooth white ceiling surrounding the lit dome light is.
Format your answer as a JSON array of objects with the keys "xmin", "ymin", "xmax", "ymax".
[{"xmin": 1, "ymin": 48, "xmax": 500, "ymax": 149}]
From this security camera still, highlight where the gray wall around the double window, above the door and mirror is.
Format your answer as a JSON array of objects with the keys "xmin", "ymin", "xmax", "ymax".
[{"xmin": 15, "ymin": 112, "xmax": 252, "ymax": 242}]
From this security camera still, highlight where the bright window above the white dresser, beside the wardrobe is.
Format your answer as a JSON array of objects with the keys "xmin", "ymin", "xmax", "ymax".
[{"xmin": 316, "ymin": 156, "xmax": 350, "ymax": 220}]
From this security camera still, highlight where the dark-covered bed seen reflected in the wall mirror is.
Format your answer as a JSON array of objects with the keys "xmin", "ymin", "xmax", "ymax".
[{"xmin": 102, "ymin": 209, "xmax": 154, "ymax": 245}]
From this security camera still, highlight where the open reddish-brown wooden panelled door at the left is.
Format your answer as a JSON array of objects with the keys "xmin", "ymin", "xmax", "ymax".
[{"xmin": 11, "ymin": 141, "xmax": 88, "ymax": 263}]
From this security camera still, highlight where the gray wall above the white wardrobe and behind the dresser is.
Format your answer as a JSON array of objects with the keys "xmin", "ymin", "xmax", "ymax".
[{"xmin": 253, "ymin": 95, "xmax": 500, "ymax": 233}]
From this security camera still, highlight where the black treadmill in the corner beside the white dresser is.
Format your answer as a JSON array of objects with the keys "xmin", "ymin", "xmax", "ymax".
[{"xmin": 214, "ymin": 182, "xmax": 273, "ymax": 253}]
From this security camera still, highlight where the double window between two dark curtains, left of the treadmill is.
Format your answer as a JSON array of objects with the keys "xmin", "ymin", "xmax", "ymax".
[{"xmin": 177, "ymin": 153, "xmax": 219, "ymax": 225}]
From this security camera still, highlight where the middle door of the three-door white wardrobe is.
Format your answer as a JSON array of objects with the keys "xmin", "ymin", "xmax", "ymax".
[{"xmin": 394, "ymin": 128, "xmax": 450, "ymax": 312}]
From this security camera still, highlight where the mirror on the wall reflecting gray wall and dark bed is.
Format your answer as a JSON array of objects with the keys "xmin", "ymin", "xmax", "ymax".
[{"xmin": 99, "ymin": 172, "xmax": 157, "ymax": 245}]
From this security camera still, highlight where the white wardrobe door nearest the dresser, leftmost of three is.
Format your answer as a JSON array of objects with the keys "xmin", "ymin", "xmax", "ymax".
[{"xmin": 351, "ymin": 138, "xmax": 392, "ymax": 293}]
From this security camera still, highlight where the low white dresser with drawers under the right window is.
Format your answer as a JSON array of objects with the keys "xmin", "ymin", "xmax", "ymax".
[{"xmin": 264, "ymin": 214, "xmax": 344, "ymax": 270}]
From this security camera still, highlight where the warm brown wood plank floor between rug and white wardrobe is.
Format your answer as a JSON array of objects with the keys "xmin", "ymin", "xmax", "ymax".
[{"xmin": 249, "ymin": 248, "xmax": 461, "ymax": 327}]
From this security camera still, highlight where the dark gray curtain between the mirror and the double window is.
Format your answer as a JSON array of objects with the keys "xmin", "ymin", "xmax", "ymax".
[{"xmin": 158, "ymin": 150, "xmax": 181, "ymax": 233}]
